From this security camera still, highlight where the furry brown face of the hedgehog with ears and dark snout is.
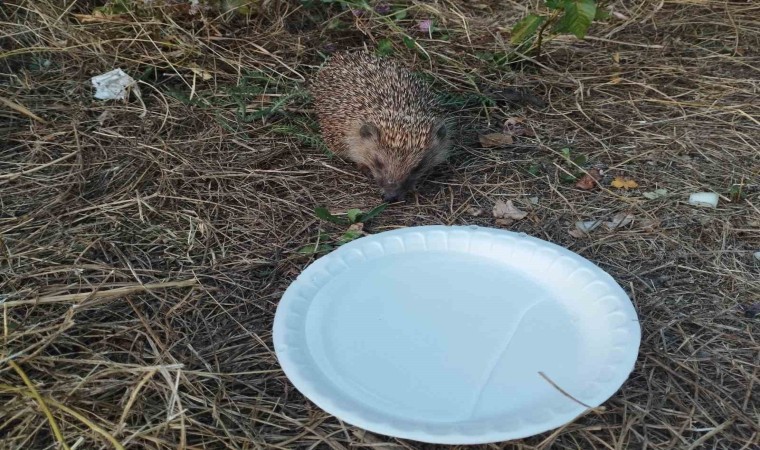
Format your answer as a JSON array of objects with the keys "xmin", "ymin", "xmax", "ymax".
[{"xmin": 349, "ymin": 121, "xmax": 450, "ymax": 202}]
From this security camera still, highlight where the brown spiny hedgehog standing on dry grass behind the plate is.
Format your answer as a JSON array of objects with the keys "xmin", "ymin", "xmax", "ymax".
[{"xmin": 309, "ymin": 51, "xmax": 452, "ymax": 202}]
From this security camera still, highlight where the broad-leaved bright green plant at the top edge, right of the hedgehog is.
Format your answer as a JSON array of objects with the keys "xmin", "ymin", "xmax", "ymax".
[{"xmin": 511, "ymin": 0, "xmax": 608, "ymax": 57}]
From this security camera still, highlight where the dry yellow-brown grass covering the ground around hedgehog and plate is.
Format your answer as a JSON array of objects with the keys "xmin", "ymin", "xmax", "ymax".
[{"xmin": 0, "ymin": 0, "xmax": 760, "ymax": 450}]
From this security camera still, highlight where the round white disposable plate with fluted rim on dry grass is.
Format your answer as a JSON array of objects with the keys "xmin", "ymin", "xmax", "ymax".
[{"xmin": 274, "ymin": 226, "xmax": 641, "ymax": 444}]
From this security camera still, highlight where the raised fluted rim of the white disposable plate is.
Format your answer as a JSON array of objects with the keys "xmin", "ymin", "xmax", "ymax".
[{"xmin": 272, "ymin": 225, "xmax": 641, "ymax": 445}]
